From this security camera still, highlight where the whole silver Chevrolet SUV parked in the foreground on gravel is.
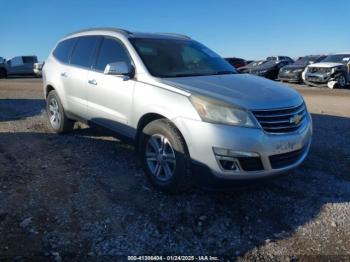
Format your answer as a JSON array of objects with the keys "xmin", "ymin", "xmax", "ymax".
[{"xmin": 43, "ymin": 29, "xmax": 312, "ymax": 192}]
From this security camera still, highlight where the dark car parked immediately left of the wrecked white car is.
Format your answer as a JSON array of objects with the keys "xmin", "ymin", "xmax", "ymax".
[{"xmin": 278, "ymin": 55, "xmax": 326, "ymax": 83}]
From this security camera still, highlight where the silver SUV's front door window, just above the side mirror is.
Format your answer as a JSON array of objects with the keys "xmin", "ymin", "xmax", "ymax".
[{"xmin": 93, "ymin": 37, "xmax": 131, "ymax": 71}]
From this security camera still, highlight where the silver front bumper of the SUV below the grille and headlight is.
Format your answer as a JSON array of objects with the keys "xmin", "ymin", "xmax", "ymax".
[{"xmin": 174, "ymin": 115, "xmax": 312, "ymax": 181}]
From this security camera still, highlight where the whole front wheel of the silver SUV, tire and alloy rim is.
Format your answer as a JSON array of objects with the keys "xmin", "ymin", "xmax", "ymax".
[{"xmin": 139, "ymin": 119, "xmax": 192, "ymax": 193}]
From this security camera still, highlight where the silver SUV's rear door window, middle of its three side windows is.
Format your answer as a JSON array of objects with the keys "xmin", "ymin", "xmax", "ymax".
[{"xmin": 70, "ymin": 36, "xmax": 99, "ymax": 68}]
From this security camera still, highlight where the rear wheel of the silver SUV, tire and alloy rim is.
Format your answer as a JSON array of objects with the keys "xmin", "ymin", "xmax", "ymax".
[{"xmin": 46, "ymin": 90, "xmax": 74, "ymax": 133}]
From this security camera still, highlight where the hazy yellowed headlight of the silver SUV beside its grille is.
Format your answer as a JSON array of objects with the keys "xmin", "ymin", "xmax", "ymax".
[{"xmin": 190, "ymin": 96, "xmax": 257, "ymax": 127}]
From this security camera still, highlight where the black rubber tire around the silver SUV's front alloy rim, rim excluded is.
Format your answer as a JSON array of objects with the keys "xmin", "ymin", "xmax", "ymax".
[{"xmin": 139, "ymin": 119, "xmax": 191, "ymax": 192}]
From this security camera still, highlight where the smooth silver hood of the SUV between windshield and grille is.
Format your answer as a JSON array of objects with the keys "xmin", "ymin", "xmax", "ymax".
[{"xmin": 158, "ymin": 74, "xmax": 303, "ymax": 110}]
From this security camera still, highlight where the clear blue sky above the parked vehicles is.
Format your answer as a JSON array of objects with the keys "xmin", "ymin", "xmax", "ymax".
[{"xmin": 0, "ymin": 0, "xmax": 350, "ymax": 60}]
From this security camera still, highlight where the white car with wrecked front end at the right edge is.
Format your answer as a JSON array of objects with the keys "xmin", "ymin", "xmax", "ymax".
[{"xmin": 304, "ymin": 53, "xmax": 350, "ymax": 88}]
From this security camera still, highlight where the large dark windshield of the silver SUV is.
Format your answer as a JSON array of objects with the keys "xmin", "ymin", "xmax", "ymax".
[{"xmin": 130, "ymin": 38, "xmax": 236, "ymax": 77}]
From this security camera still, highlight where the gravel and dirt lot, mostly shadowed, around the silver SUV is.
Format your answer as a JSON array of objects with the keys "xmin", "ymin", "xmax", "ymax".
[{"xmin": 0, "ymin": 79, "xmax": 350, "ymax": 261}]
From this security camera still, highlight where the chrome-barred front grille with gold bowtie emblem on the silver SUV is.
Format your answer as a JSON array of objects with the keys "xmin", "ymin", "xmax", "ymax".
[{"xmin": 253, "ymin": 103, "xmax": 307, "ymax": 133}]
